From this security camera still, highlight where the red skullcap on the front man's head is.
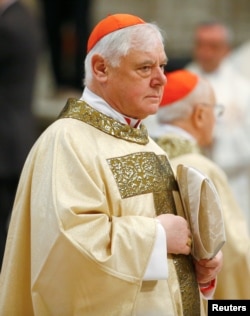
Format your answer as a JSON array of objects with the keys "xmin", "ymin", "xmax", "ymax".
[{"xmin": 87, "ymin": 14, "xmax": 146, "ymax": 53}]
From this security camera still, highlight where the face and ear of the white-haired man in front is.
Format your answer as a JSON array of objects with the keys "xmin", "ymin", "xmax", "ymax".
[{"xmin": 104, "ymin": 42, "xmax": 166, "ymax": 119}]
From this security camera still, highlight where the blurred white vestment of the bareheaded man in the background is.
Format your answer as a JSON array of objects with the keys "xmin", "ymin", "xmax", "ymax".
[{"xmin": 187, "ymin": 60, "xmax": 250, "ymax": 229}]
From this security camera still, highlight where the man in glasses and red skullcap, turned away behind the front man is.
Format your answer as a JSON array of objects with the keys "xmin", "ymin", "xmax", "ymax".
[{"xmin": 157, "ymin": 70, "xmax": 250, "ymax": 299}]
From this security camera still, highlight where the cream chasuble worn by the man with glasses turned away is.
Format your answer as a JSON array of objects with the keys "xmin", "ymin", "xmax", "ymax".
[{"xmin": 157, "ymin": 132, "xmax": 250, "ymax": 299}]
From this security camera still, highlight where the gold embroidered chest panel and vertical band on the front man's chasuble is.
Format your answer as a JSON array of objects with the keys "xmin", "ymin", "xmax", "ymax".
[{"xmin": 107, "ymin": 152, "xmax": 200, "ymax": 316}]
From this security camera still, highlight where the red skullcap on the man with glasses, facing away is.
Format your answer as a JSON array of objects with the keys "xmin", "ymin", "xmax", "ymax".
[{"xmin": 160, "ymin": 69, "xmax": 198, "ymax": 107}]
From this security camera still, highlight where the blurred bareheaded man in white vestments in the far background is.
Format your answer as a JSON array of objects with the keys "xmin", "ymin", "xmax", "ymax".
[{"xmin": 187, "ymin": 22, "xmax": 250, "ymax": 229}]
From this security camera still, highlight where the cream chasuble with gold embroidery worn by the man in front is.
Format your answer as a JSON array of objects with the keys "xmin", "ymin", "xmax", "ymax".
[{"xmin": 0, "ymin": 99, "xmax": 204, "ymax": 316}]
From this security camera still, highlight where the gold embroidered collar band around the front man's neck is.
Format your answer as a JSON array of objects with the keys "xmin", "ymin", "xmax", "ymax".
[{"xmin": 58, "ymin": 98, "xmax": 149, "ymax": 145}]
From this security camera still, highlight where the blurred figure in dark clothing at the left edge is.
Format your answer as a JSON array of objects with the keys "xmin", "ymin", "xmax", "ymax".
[{"xmin": 0, "ymin": 0, "xmax": 40, "ymax": 270}]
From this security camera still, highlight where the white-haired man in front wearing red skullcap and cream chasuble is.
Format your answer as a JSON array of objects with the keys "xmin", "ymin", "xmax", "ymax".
[{"xmin": 0, "ymin": 14, "xmax": 222, "ymax": 316}]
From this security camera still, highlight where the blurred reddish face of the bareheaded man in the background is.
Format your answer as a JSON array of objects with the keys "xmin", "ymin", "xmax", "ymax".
[{"xmin": 194, "ymin": 25, "xmax": 230, "ymax": 72}]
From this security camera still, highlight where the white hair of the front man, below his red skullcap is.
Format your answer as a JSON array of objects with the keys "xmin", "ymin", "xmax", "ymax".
[{"xmin": 84, "ymin": 23, "xmax": 164, "ymax": 85}]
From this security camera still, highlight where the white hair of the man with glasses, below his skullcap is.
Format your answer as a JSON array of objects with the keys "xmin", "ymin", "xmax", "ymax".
[{"xmin": 157, "ymin": 78, "xmax": 211, "ymax": 124}]
